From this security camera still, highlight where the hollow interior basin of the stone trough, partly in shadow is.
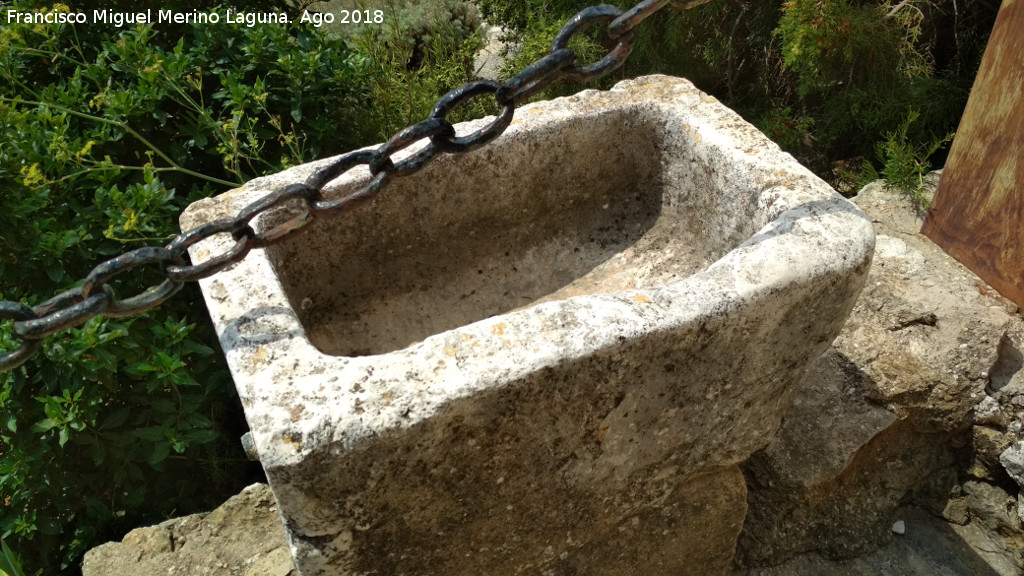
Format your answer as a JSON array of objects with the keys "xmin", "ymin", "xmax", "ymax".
[{"xmin": 261, "ymin": 111, "xmax": 735, "ymax": 356}]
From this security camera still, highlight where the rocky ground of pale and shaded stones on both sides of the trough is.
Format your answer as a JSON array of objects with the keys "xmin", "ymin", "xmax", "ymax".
[{"xmin": 83, "ymin": 172, "xmax": 1024, "ymax": 576}]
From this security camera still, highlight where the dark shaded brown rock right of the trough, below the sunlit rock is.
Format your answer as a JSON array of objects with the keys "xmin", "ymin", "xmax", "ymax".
[{"xmin": 739, "ymin": 349, "xmax": 952, "ymax": 566}]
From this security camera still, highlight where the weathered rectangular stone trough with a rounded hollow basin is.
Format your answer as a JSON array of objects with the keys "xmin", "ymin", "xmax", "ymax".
[{"xmin": 181, "ymin": 77, "xmax": 873, "ymax": 576}]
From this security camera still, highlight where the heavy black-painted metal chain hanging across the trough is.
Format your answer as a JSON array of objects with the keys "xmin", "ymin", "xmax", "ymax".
[{"xmin": 0, "ymin": 0, "xmax": 708, "ymax": 372}]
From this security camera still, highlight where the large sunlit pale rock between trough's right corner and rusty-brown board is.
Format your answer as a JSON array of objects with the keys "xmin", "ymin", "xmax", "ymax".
[{"xmin": 835, "ymin": 182, "xmax": 1021, "ymax": 431}]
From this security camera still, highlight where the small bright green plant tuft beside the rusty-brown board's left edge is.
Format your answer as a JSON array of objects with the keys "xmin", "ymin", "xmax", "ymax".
[{"xmin": 876, "ymin": 110, "xmax": 953, "ymax": 210}]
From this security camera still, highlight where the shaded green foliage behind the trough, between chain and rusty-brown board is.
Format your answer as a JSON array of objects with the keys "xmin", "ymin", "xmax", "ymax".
[{"xmin": 479, "ymin": 0, "xmax": 998, "ymax": 189}]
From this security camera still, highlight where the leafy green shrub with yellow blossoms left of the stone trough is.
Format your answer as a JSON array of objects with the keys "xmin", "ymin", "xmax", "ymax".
[{"xmin": 0, "ymin": 0, "xmax": 484, "ymax": 574}]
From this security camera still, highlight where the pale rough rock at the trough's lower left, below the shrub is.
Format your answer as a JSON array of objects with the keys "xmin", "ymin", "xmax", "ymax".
[{"xmin": 82, "ymin": 484, "xmax": 298, "ymax": 576}]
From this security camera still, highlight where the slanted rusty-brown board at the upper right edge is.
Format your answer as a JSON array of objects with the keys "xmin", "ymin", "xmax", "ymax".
[{"xmin": 922, "ymin": 0, "xmax": 1024, "ymax": 307}]
